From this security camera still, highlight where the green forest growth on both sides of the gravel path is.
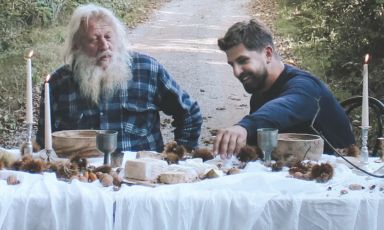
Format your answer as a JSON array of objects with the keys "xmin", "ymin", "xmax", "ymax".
[{"xmin": 0, "ymin": 0, "xmax": 384, "ymax": 147}]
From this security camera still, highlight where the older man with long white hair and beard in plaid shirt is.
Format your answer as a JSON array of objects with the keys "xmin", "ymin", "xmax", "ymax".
[{"xmin": 36, "ymin": 5, "xmax": 202, "ymax": 151}]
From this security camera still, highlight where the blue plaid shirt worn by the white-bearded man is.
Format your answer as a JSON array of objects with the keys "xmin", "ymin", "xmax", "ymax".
[{"xmin": 36, "ymin": 52, "xmax": 203, "ymax": 152}]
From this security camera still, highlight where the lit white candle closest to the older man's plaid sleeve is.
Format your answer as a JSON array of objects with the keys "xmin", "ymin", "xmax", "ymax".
[{"xmin": 44, "ymin": 75, "xmax": 52, "ymax": 150}]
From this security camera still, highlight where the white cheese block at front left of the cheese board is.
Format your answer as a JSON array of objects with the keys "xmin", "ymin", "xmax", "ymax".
[{"xmin": 124, "ymin": 158, "xmax": 168, "ymax": 181}]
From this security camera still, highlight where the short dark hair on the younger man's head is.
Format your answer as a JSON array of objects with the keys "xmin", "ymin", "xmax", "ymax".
[{"xmin": 218, "ymin": 20, "xmax": 275, "ymax": 51}]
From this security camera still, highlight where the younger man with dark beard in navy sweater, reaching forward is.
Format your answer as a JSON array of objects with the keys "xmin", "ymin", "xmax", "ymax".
[{"xmin": 213, "ymin": 20, "xmax": 355, "ymax": 158}]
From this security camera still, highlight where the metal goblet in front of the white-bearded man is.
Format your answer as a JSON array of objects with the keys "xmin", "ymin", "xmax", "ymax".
[{"xmin": 96, "ymin": 130, "xmax": 117, "ymax": 164}]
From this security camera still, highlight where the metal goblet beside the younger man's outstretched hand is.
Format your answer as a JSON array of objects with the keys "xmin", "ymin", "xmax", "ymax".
[{"xmin": 257, "ymin": 128, "xmax": 279, "ymax": 166}]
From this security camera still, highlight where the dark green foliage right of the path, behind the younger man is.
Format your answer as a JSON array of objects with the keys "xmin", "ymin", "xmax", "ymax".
[{"xmin": 280, "ymin": 0, "xmax": 384, "ymax": 99}]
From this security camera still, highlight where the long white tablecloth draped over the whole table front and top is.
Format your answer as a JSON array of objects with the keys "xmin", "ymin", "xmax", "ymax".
[{"xmin": 0, "ymin": 150, "xmax": 384, "ymax": 230}]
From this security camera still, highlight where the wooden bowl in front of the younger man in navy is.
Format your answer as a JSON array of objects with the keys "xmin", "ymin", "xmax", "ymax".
[{"xmin": 272, "ymin": 133, "xmax": 324, "ymax": 167}]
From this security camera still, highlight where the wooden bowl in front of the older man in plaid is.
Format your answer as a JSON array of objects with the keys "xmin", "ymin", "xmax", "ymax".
[{"xmin": 52, "ymin": 130, "xmax": 103, "ymax": 158}]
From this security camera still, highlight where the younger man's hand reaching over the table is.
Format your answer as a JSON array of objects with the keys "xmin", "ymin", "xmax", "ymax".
[{"xmin": 213, "ymin": 125, "xmax": 247, "ymax": 159}]
